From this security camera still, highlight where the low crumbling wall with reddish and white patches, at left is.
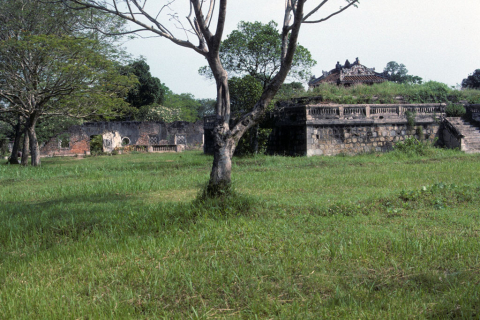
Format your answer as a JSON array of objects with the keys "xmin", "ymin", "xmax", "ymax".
[{"xmin": 40, "ymin": 121, "xmax": 203, "ymax": 156}]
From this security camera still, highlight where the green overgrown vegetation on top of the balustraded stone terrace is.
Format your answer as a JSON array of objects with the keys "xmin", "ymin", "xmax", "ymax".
[{"xmin": 302, "ymin": 81, "xmax": 480, "ymax": 104}]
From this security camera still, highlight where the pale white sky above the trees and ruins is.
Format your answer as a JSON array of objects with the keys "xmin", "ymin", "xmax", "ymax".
[{"xmin": 125, "ymin": 0, "xmax": 480, "ymax": 98}]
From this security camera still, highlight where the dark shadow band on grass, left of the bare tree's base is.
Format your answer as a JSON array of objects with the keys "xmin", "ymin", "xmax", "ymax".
[{"xmin": 0, "ymin": 188, "xmax": 258, "ymax": 249}]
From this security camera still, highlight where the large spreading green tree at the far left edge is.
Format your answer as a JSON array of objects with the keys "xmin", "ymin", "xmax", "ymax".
[{"xmin": 0, "ymin": 0, "xmax": 134, "ymax": 166}]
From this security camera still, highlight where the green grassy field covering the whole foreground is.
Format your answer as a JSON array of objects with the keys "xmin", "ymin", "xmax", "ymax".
[{"xmin": 0, "ymin": 150, "xmax": 480, "ymax": 319}]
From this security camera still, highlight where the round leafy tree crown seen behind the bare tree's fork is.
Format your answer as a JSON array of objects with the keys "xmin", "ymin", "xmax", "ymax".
[{"xmin": 199, "ymin": 21, "xmax": 316, "ymax": 88}]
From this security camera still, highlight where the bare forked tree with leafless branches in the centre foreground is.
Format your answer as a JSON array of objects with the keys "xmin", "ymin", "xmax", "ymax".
[{"xmin": 62, "ymin": 0, "xmax": 359, "ymax": 196}]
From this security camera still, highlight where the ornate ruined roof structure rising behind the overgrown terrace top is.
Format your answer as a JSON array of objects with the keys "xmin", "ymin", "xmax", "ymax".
[{"xmin": 308, "ymin": 58, "xmax": 390, "ymax": 88}]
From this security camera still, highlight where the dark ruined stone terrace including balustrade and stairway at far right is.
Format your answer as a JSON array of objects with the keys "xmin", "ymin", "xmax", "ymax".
[{"xmin": 204, "ymin": 97, "xmax": 480, "ymax": 156}]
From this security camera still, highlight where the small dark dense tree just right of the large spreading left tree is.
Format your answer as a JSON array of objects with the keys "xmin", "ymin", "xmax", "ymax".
[{"xmin": 125, "ymin": 59, "xmax": 167, "ymax": 109}]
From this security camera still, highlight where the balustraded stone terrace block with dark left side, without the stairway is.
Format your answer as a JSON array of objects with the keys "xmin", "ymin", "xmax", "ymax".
[{"xmin": 268, "ymin": 100, "xmax": 445, "ymax": 156}]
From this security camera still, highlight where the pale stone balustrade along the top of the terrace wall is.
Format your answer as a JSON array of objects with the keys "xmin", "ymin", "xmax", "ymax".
[{"xmin": 306, "ymin": 103, "xmax": 444, "ymax": 120}]
